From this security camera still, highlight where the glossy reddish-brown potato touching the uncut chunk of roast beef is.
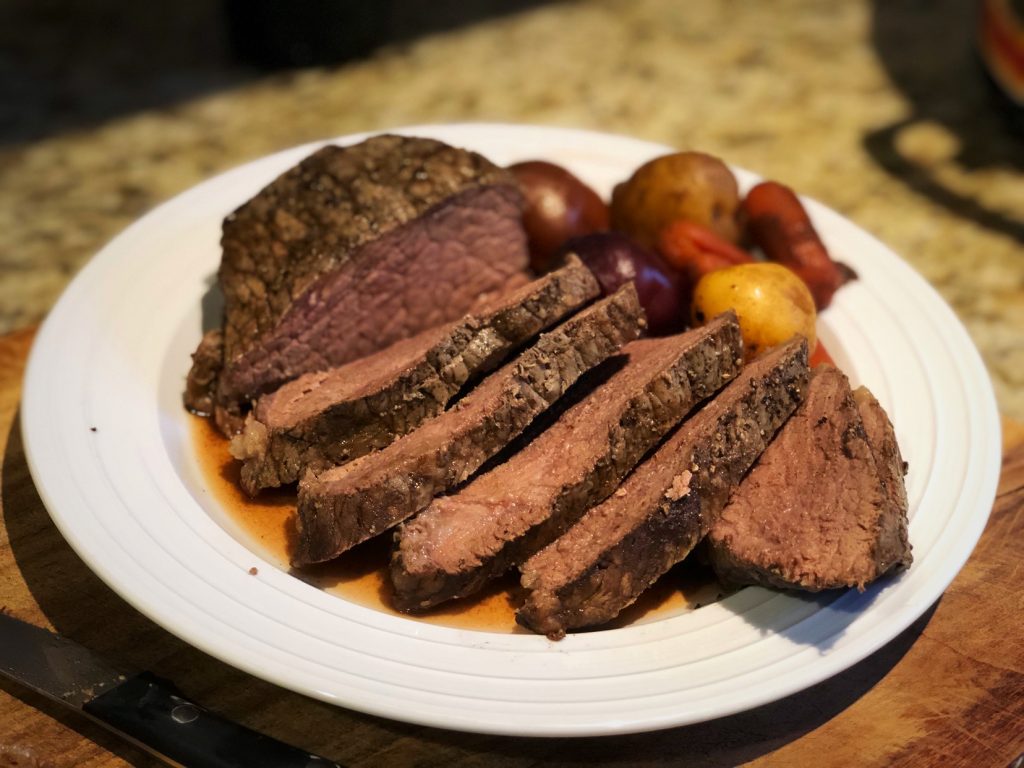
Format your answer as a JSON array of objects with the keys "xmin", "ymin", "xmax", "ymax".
[{"xmin": 508, "ymin": 160, "xmax": 608, "ymax": 273}]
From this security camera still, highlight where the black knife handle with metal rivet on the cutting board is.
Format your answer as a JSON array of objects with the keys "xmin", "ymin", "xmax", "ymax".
[{"xmin": 83, "ymin": 672, "xmax": 339, "ymax": 768}]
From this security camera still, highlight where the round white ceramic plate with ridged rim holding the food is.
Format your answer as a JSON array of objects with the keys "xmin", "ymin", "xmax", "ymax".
[{"xmin": 22, "ymin": 125, "xmax": 999, "ymax": 735}]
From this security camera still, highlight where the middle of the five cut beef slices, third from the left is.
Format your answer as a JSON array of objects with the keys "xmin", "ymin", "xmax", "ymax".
[{"xmin": 391, "ymin": 312, "xmax": 743, "ymax": 610}]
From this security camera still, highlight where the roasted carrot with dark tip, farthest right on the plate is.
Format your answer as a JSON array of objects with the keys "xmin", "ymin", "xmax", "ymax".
[{"xmin": 742, "ymin": 181, "xmax": 856, "ymax": 309}]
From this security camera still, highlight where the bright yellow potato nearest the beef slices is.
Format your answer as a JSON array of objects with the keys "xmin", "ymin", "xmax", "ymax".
[{"xmin": 690, "ymin": 262, "xmax": 817, "ymax": 359}]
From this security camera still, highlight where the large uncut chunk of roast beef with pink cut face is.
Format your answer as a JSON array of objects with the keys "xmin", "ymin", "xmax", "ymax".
[{"xmin": 198, "ymin": 135, "xmax": 527, "ymax": 399}]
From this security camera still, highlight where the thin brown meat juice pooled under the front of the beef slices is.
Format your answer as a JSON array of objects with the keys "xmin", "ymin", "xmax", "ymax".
[{"xmin": 189, "ymin": 416, "xmax": 723, "ymax": 633}]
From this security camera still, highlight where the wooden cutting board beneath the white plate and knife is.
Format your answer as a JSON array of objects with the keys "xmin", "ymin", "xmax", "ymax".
[{"xmin": 0, "ymin": 330, "xmax": 1024, "ymax": 768}]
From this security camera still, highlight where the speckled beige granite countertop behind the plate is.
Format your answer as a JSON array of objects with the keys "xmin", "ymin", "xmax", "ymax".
[{"xmin": 0, "ymin": 0, "xmax": 1024, "ymax": 419}]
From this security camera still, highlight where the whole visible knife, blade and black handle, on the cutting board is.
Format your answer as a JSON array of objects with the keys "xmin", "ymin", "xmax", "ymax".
[{"xmin": 0, "ymin": 611, "xmax": 340, "ymax": 768}]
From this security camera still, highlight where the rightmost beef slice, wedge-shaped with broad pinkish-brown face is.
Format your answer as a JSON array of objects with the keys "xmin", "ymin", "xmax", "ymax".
[{"xmin": 708, "ymin": 367, "xmax": 910, "ymax": 592}]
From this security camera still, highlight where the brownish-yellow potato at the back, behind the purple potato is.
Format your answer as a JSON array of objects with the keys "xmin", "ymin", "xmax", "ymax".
[{"xmin": 611, "ymin": 152, "xmax": 739, "ymax": 248}]
